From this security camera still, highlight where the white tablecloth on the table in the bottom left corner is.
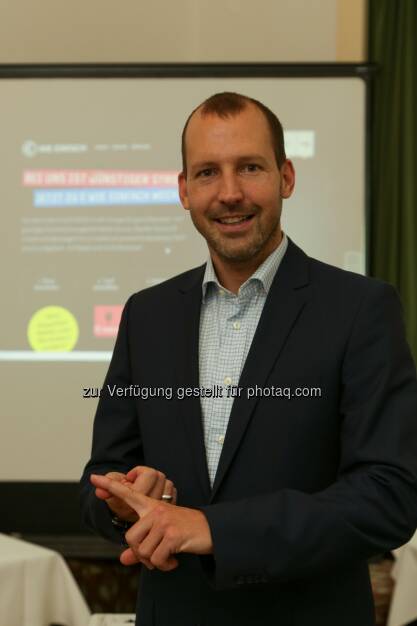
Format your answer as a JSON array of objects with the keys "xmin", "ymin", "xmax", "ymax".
[{"xmin": 0, "ymin": 534, "xmax": 90, "ymax": 626}]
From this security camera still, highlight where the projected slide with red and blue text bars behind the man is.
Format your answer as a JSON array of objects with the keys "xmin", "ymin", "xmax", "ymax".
[{"xmin": 0, "ymin": 79, "xmax": 364, "ymax": 361}]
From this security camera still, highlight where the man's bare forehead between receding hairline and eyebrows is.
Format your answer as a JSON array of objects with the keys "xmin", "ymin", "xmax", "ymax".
[{"xmin": 185, "ymin": 105, "xmax": 274, "ymax": 161}]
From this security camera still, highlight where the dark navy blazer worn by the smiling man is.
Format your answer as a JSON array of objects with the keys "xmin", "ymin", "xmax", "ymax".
[{"xmin": 82, "ymin": 241, "xmax": 417, "ymax": 626}]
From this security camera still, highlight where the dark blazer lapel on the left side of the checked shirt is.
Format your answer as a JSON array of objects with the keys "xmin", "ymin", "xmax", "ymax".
[{"xmin": 177, "ymin": 267, "xmax": 211, "ymax": 502}]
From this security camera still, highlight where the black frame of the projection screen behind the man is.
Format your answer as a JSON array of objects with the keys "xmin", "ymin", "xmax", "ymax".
[{"xmin": 0, "ymin": 63, "xmax": 378, "ymax": 540}]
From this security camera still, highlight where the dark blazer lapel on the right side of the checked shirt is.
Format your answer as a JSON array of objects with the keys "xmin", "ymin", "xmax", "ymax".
[{"xmin": 211, "ymin": 240, "xmax": 308, "ymax": 501}]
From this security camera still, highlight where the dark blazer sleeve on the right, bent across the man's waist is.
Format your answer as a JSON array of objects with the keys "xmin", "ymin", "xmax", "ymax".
[{"xmin": 200, "ymin": 281, "xmax": 417, "ymax": 588}]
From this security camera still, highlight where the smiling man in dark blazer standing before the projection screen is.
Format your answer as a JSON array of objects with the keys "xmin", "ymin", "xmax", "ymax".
[{"xmin": 82, "ymin": 93, "xmax": 417, "ymax": 626}]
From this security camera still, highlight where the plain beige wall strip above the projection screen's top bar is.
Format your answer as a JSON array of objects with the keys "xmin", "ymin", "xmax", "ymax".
[{"xmin": 0, "ymin": 0, "xmax": 366, "ymax": 63}]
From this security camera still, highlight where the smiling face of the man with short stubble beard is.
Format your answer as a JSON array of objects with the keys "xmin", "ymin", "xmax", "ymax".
[{"xmin": 179, "ymin": 105, "xmax": 294, "ymax": 263}]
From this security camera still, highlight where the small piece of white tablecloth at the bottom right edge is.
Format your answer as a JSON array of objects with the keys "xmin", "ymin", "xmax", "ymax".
[{"xmin": 387, "ymin": 532, "xmax": 417, "ymax": 626}]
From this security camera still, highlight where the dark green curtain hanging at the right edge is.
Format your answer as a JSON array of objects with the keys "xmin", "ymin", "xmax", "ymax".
[{"xmin": 368, "ymin": 0, "xmax": 417, "ymax": 359}]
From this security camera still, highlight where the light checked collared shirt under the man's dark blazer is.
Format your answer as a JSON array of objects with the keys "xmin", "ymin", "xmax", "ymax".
[{"xmin": 199, "ymin": 233, "xmax": 288, "ymax": 485}]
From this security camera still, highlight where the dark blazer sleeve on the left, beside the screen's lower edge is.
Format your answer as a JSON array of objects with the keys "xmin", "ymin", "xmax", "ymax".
[{"xmin": 80, "ymin": 298, "xmax": 143, "ymax": 543}]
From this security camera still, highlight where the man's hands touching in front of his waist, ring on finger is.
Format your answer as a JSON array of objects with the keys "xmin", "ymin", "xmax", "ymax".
[{"xmin": 90, "ymin": 466, "xmax": 213, "ymax": 572}]
